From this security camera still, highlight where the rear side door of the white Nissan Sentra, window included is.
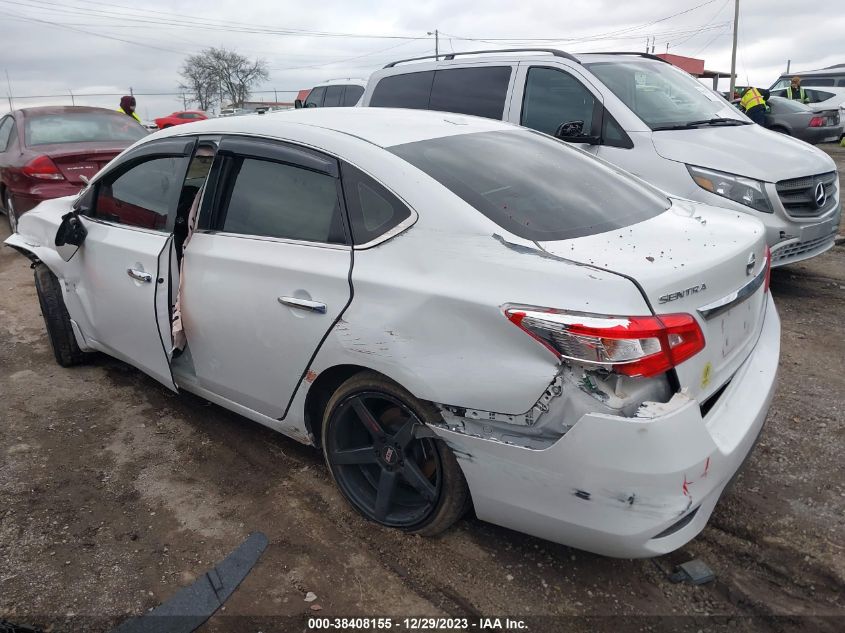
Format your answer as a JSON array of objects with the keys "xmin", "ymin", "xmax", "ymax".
[{"xmin": 181, "ymin": 138, "xmax": 352, "ymax": 418}]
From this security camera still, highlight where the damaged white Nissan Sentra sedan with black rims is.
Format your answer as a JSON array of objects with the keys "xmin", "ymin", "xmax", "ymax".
[{"xmin": 6, "ymin": 108, "xmax": 780, "ymax": 557}]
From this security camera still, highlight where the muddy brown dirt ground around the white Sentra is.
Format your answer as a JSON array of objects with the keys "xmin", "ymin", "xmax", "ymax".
[{"xmin": 0, "ymin": 148, "xmax": 845, "ymax": 632}]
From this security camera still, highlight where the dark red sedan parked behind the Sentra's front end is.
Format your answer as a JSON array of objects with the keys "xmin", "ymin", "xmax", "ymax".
[{"xmin": 0, "ymin": 106, "xmax": 148, "ymax": 233}]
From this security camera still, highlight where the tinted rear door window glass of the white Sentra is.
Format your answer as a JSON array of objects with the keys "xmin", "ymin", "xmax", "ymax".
[{"xmin": 219, "ymin": 156, "xmax": 346, "ymax": 244}]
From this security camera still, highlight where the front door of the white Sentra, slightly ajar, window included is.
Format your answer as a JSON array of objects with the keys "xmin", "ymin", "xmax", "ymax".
[{"xmin": 65, "ymin": 140, "xmax": 193, "ymax": 390}]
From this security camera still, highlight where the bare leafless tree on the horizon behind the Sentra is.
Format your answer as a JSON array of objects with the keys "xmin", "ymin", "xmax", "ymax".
[{"xmin": 179, "ymin": 48, "xmax": 270, "ymax": 110}]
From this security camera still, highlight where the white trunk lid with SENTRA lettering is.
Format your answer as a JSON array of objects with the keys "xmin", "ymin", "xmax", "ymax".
[{"xmin": 540, "ymin": 198, "xmax": 766, "ymax": 400}]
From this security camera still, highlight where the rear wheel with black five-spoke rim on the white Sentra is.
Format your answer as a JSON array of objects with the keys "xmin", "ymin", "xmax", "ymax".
[{"xmin": 323, "ymin": 372, "xmax": 469, "ymax": 536}]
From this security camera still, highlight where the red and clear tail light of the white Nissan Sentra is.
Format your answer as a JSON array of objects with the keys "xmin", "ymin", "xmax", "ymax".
[{"xmin": 504, "ymin": 305, "xmax": 704, "ymax": 377}]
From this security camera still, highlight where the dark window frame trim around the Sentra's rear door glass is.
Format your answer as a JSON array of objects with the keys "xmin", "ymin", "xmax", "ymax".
[{"xmin": 203, "ymin": 135, "xmax": 352, "ymax": 250}]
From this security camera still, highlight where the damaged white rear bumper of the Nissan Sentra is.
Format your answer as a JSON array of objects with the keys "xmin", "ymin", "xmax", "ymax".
[{"xmin": 434, "ymin": 297, "xmax": 780, "ymax": 558}]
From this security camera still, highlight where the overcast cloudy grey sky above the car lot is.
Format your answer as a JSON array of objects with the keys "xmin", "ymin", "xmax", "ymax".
[{"xmin": 0, "ymin": 0, "xmax": 845, "ymax": 119}]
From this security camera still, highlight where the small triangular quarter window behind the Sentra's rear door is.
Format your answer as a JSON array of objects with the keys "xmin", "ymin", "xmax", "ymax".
[{"xmin": 342, "ymin": 165, "xmax": 411, "ymax": 244}]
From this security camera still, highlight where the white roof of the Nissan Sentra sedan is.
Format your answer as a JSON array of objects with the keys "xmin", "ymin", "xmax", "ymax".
[{"xmin": 152, "ymin": 108, "xmax": 521, "ymax": 147}]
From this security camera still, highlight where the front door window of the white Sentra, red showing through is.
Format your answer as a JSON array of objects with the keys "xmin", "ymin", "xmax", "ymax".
[{"xmin": 92, "ymin": 156, "xmax": 188, "ymax": 231}]
